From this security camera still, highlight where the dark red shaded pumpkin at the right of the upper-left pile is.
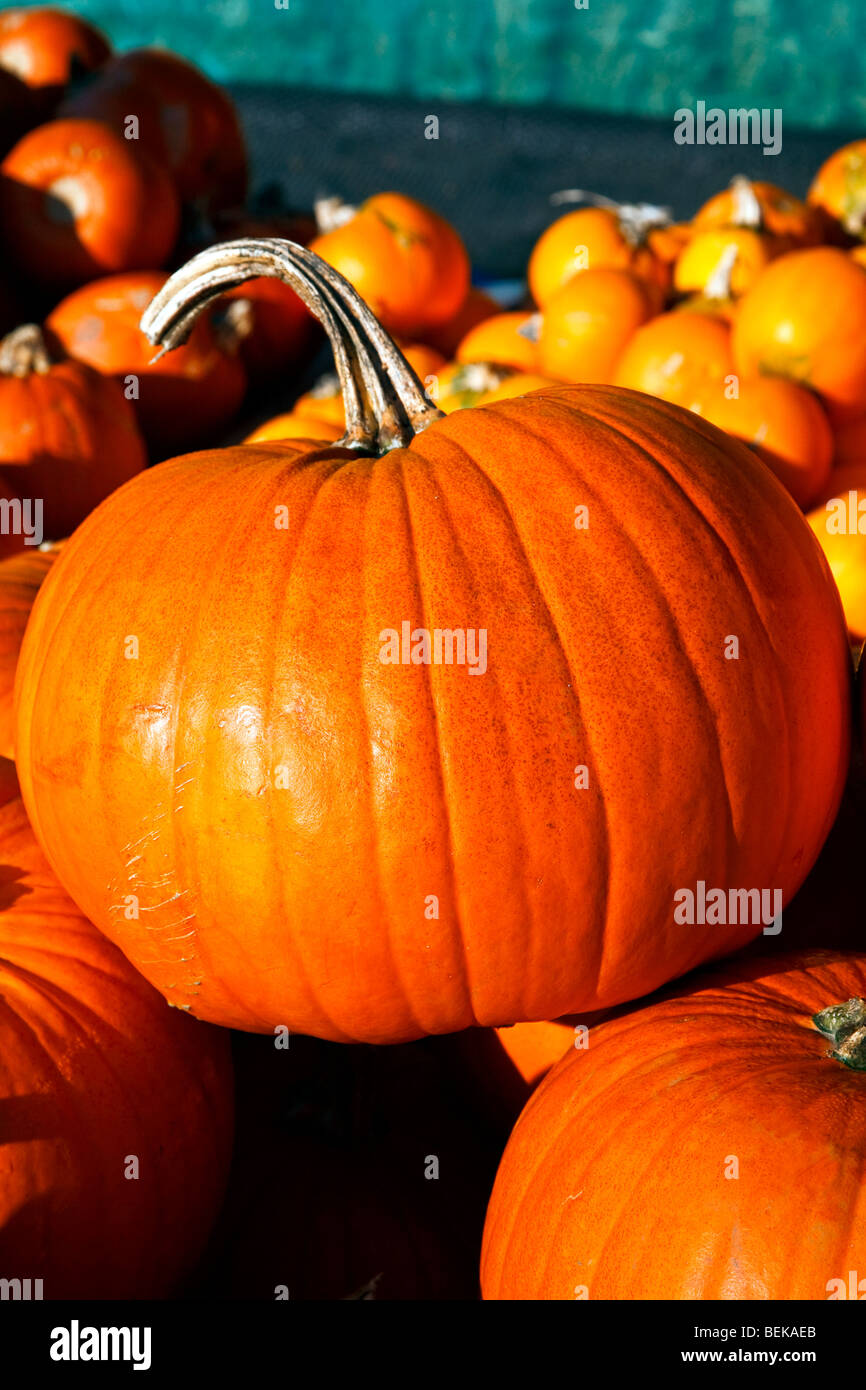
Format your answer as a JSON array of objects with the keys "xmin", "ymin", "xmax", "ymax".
[{"xmin": 60, "ymin": 49, "xmax": 247, "ymax": 214}]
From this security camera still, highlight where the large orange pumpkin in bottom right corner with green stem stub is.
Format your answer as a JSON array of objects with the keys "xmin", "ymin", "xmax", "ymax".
[{"xmin": 481, "ymin": 952, "xmax": 866, "ymax": 1300}]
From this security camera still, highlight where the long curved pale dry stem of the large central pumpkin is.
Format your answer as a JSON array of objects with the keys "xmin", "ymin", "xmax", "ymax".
[{"xmin": 140, "ymin": 238, "xmax": 442, "ymax": 453}]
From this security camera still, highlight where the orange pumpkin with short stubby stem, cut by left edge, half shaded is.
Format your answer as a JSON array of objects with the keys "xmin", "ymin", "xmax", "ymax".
[{"xmin": 0, "ymin": 324, "xmax": 147, "ymax": 539}]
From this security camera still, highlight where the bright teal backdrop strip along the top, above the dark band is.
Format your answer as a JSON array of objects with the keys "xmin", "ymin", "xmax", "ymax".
[{"xmin": 8, "ymin": 0, "xmax": 866, "ymax": 128}]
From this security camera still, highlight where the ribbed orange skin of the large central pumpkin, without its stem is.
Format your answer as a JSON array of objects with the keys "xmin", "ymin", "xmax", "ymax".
[{"xmin": 17, "ymin": 386, "xmax": 851, "ymax": 1043}]
